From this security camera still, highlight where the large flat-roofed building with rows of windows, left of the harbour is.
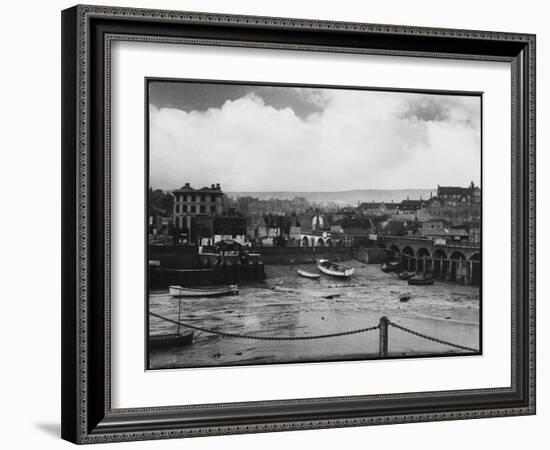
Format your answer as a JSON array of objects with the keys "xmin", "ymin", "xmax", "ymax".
[{"xmin": 172, "ymin": 183, "xmax": 223, "ymax": 232}]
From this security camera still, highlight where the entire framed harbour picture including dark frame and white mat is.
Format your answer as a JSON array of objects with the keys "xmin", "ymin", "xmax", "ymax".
[{"xmin": 62, "ymin": 6, "xmax": 535, "ymax": 443}]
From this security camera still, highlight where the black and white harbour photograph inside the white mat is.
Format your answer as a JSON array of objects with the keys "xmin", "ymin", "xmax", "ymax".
[{"xmin": 146, "ymin": 78, "xmax": 482, "ymax": 369}]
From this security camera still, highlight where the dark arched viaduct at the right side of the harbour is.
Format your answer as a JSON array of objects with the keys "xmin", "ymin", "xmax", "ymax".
[{"xmin": 371, "ymin": 236, "xmax": 481, "ymax": 285}]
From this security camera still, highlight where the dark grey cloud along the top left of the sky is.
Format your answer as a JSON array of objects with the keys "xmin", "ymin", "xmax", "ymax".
[{"xmin": 149, "ymin": 81, "xmax": 326, "ymax": 118}]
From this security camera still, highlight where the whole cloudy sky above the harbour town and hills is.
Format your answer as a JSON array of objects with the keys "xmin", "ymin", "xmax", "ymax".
[{"xmin": 149, "ymin": 81, "xmax": 481, "ymax": 192}]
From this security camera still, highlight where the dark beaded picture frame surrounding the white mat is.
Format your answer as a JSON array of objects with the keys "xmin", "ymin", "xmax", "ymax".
[{"xmin": 62, "ymin": 6, "xmax": 535, "ymax": 443}]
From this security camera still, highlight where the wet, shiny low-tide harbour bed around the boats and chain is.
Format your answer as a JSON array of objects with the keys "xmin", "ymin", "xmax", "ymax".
[{"xmin": 149, "ymin": 261, "xmax": 480, "ymax": 369}]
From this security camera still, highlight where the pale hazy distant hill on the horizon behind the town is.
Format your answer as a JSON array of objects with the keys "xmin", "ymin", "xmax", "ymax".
[{"xmin": 226, "ymin": 189, "xmax": 437, "ymax": 206}]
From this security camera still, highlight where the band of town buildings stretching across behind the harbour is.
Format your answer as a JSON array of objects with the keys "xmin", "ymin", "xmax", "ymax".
[{"xmin": 149, "ymin": 183, "xmax": 481, "ymax": 245}]
